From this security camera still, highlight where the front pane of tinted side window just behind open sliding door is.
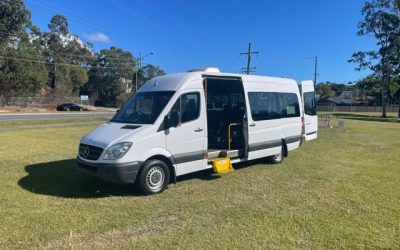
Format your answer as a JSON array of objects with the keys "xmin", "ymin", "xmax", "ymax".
[{"xmin": 248, "ymin": 92, "xmax": 281, "ymax": 121}]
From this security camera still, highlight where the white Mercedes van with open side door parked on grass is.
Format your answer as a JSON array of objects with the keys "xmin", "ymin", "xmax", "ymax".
[{"xmin": 77, "ymin": 68, "xmax": 318, "ymax": 194}]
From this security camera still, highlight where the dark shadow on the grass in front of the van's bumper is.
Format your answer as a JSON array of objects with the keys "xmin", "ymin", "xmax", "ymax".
[{"xmin": 18, "ymin": 159, "xmax": 140, "ymax": 198}]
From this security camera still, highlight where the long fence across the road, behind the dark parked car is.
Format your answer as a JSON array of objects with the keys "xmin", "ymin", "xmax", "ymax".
[{"xmin": 0, "ymin": 97, "xmax": 94, "ymax": 108}]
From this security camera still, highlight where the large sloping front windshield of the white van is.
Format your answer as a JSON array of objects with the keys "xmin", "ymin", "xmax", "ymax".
[{"xmin": 111, "ymin": 91, "xmax": 174, "ymax": 124}]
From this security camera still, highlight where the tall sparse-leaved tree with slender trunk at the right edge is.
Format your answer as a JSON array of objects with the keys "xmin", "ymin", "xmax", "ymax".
[{"xmin": 349, "ymin": 0, "xmax": 400, "ymax": 117}]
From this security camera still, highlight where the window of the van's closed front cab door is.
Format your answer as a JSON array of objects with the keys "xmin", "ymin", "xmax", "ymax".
[{"xmin": 169, "ymin": 93, "xmax": 200, "ymax": 125}]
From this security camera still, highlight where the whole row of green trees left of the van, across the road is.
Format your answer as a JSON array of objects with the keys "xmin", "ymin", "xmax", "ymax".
[{"xmin": 0, "ymin": 0, "xmax": 165, "ymax": 106}]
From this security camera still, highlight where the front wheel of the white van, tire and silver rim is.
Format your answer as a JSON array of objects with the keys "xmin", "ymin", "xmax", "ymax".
[{"xmin": 136, "ymin": 160, "xmax": 170, "ymax": 195}]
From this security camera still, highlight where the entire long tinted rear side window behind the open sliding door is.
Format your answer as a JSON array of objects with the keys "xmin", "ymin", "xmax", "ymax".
[{"xmin": 248, "ymin": 92, "xmax": 300, "ymax": 121}]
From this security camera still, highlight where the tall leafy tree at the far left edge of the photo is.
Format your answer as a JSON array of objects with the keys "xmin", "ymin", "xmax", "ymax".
[{"xmin": 0, "ymin": 0, "xmax": 47, "ymax": 97}]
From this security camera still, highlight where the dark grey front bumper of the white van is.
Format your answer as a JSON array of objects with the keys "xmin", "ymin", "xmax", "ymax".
[{"xmin": 76, "ymin": 156, "xmax": 142, "ymax": 184}]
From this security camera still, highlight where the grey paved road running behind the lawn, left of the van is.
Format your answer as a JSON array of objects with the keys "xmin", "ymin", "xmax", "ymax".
[{"xmin": 0, "ymin": 112, "xmax": 115, "ymax": 122}]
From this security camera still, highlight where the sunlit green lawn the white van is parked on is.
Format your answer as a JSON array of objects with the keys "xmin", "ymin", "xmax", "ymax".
[{"xmin": 0, "ymin": 120, "xmax": 400, "ymax": 249}]
